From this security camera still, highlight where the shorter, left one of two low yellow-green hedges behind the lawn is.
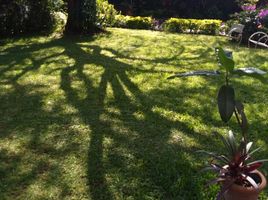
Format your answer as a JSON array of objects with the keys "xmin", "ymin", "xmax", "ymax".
[{"xmin": 114, "ymin": 15, "xmax": 154, "ymax": 29}]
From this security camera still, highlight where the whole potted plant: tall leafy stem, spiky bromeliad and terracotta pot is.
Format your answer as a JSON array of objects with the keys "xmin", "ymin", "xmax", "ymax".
[{"xmin": 168, "ymin": 47, "xmax": 267, "ymax": 200}]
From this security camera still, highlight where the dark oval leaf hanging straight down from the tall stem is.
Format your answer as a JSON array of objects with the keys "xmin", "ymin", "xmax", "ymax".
[{"xmin": 218, "ymin": 85, "xmax": 235, "ymax": 123}]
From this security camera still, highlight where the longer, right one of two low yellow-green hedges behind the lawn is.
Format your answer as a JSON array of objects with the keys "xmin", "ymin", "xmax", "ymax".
[{"xmin": 163, "ymin": 18, "xmax": 222, "ymax": 35}]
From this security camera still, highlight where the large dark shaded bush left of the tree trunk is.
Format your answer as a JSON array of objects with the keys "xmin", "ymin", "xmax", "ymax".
[{"xmin": 0, "ymin": 0, "xmax": 63, "ymax": 36}]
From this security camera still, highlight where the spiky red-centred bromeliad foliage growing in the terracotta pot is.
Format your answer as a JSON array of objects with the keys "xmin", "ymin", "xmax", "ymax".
[{"xmin": 198, "ymin": 131, "xmax": 268, "ymax": 200}]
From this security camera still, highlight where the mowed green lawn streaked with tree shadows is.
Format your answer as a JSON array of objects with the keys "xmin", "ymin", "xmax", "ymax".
[{"xmin": 0, "ymin": 29, "xmax": 268, "ymax": 200}]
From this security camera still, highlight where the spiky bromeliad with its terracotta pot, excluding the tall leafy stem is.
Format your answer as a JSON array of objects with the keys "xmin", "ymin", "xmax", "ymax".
[{"xmin": 199, "ymin": 131, "xmax": 268, "ymax": 200}]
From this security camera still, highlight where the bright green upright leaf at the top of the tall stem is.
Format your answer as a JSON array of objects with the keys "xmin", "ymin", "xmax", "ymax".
[{"xmin": 216, "ymin": 47, "xmax": 235, "ymax": 72}]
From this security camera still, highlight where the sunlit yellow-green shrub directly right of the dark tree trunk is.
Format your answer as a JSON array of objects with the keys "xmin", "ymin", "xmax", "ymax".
[{"xmin": 97, "ymin": 0, "xmax": 120, "ymax": 27}]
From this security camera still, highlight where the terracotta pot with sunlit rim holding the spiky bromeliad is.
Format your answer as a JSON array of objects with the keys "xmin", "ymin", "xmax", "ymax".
[{"xmin": 223, "ymin": 170, "xmax": 266, "ymax": 200}]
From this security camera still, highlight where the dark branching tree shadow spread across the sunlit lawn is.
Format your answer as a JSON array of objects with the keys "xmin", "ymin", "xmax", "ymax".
[{"xmin": 0, "ymin": 32, "xmax": 266, "ymax": 200}]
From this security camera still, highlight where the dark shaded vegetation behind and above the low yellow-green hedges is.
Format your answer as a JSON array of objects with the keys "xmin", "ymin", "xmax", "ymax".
[{"xmin": 109, "ymin": 0, "xmax": 240, "ymax": 20}]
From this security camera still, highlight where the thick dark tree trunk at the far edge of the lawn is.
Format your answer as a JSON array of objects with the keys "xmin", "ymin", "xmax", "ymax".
[{"xmin": 65, "ymin": 0, "xmax": 96, "ymax": 34}]
